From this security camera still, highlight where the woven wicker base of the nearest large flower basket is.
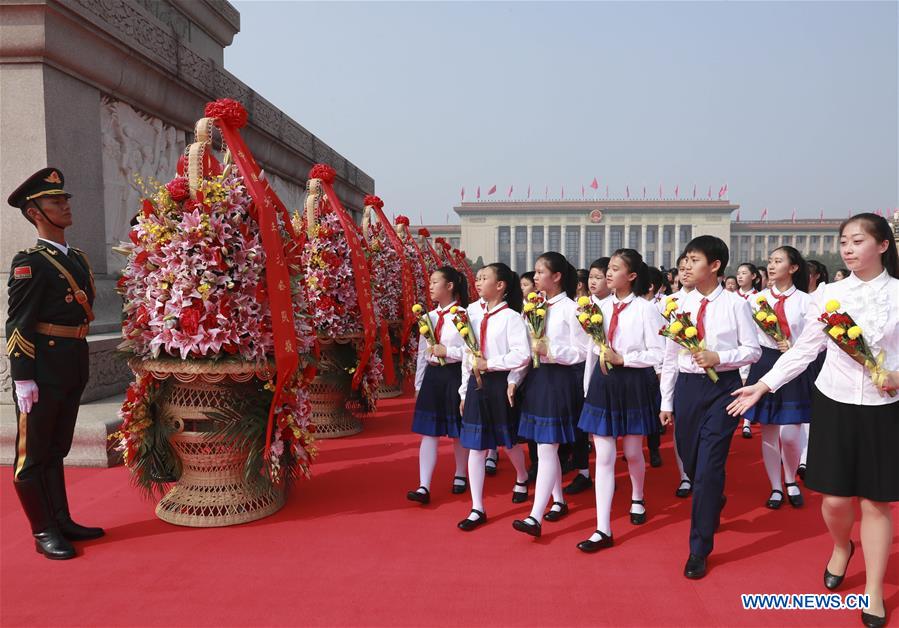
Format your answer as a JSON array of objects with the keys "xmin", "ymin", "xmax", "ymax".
[{"xmin": 131, "ymin": 360, "xmax": 286, "ymax": 528}]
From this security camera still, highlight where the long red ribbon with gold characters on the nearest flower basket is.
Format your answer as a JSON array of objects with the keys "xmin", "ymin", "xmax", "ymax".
[{"xmin": 217, "ymin": 119, "xmax": 300, "ymax": 460}]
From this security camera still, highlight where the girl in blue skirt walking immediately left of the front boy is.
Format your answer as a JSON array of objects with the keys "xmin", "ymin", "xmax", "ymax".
[{"xmin": 578, "ymin": 249, "xmax": 664, "ymax": 552}]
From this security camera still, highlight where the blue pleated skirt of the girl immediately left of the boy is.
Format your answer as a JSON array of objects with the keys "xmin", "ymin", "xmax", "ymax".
[{"xmin": 578, "ymin": 362, "xmax": 661, "ymax": 437}]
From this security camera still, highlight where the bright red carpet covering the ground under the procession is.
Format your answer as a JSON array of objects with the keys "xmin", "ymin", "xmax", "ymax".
[{"xmin": 0, "ymin": 398, "xmax": 899, "ymax": 626}]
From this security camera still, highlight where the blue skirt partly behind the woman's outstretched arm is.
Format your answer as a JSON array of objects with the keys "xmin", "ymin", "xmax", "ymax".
[{"xmin": 746, "ymin": 347, "xmax": 820, "ymax": 425}]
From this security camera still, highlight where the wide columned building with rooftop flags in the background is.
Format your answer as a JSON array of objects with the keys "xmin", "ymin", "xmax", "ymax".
[{"xmin": 418, "ymin": 199, "xmax": 841, "ymax": 272}]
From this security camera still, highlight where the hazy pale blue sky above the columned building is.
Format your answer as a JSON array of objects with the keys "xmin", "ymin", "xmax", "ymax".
[{"xmin": 225, "ymin": 1, "xmax": 899, "ymax": 223}]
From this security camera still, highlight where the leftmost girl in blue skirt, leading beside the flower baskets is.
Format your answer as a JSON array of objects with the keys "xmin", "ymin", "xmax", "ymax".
[{"xmin": 406, "ymin": 266, "xmax": 468, "ymax": 504}]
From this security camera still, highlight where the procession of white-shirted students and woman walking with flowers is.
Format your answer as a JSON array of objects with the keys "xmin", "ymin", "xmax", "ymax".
[{"xmin": 407, "ymin": 214, "xmax": 899, "ymax": 625}]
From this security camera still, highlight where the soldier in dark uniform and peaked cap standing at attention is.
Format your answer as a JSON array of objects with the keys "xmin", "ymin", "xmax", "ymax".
[{"xmin": 6, "ymin": 168, "xmax": 103, "ymax": 560}]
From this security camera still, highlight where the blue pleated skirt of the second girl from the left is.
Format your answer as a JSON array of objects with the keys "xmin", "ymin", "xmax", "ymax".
[{"xmin": 459, "ymin": 371, "xmax": 518, "ymax": 450}]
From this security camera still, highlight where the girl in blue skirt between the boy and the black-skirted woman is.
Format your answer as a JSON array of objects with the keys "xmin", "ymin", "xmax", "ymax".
[{"xmin": 746, "ymin": 246, "xmax": 817, "ymax": 510}]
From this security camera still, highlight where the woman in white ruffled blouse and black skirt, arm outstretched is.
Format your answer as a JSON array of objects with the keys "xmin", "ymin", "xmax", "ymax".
[{"xmin": 728, "ymin": 213, "xmax": 899, "ymax": 626}]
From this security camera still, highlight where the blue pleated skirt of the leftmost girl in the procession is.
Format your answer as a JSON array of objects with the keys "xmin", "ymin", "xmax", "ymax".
[{"xmin": 412, "ymin": 362, "xmax": 462, "ymax": 438}]
